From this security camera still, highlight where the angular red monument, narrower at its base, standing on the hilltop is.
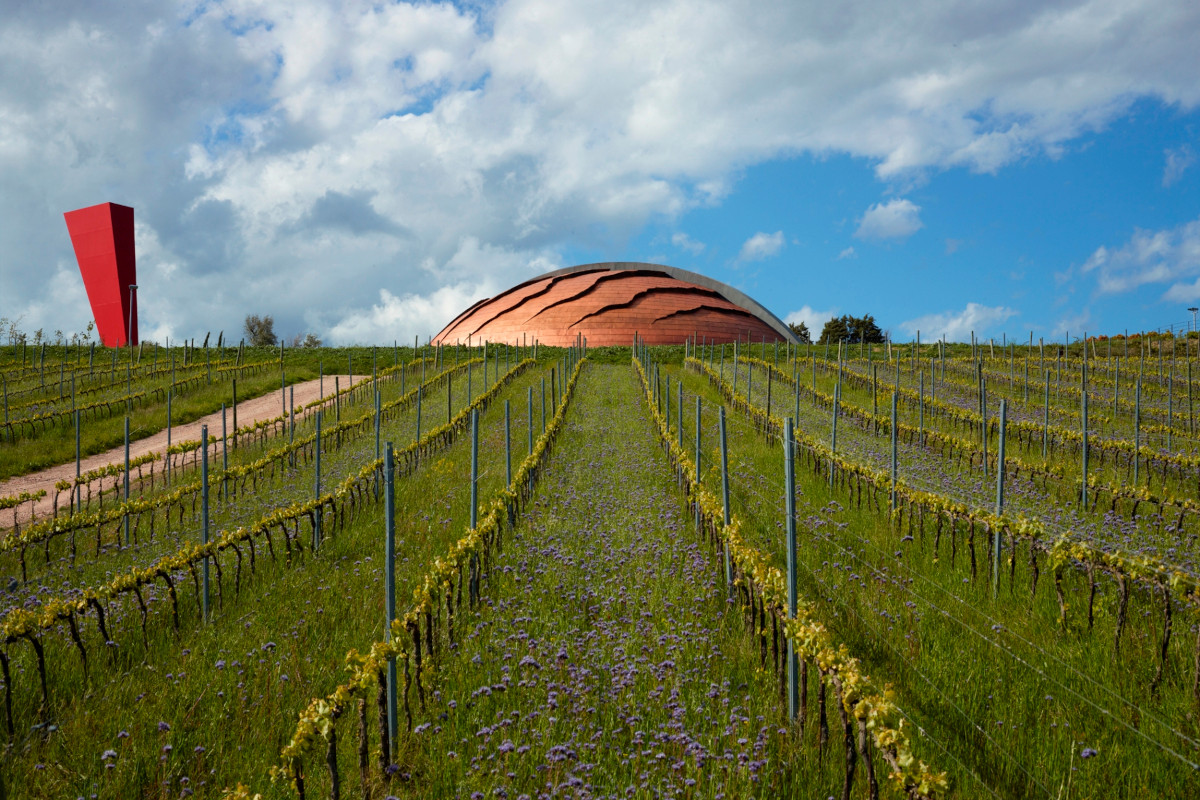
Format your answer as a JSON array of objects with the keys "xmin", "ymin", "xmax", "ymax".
[{"xmin": 62, "ymin": 203, "xmax": 138, "ymax": 347}]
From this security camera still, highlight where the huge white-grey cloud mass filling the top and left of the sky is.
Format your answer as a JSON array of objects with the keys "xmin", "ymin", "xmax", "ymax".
[{"xmin": 0, "ymin": 0, "xmax": 1200, "ymax": 338}]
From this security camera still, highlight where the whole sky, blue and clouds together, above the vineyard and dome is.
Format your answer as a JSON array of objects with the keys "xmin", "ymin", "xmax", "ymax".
[{"xmin": 0, "ymin": 0, "xmax": 1200, "ymax": 343}]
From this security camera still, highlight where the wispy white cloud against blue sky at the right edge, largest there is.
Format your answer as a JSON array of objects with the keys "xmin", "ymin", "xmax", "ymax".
[{"xmin": 1080, "ymin": 218, "xmax": 1200, "ymax": 300}]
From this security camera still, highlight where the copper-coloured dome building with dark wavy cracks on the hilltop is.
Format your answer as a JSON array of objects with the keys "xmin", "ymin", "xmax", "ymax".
[{"xmin": 433, "ymin": 261, "xmax": 797, "ymax": 347}]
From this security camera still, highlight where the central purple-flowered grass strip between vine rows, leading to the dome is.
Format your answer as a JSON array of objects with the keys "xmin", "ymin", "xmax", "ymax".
[{"xmin": 388, "ymin": 365, "xmax": 841, "ymax": 798}]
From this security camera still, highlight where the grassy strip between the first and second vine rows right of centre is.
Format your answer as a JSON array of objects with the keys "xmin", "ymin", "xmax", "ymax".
[{"xmin": 661, "ymin": 357, "xmax": 1198, "ymax": 796}]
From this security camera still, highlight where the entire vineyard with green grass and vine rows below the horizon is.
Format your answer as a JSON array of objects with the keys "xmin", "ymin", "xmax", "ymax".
[{"xmin": 0, "ymin": 337, "xmax": 1200, "ymax": 800}]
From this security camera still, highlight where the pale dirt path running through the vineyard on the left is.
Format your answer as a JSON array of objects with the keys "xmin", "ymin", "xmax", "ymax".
[{"xmin": 0, "ymin": 375, "xmax": 371, "ymax": 535}]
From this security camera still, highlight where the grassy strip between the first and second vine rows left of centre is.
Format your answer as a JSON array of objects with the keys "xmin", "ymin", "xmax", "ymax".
[{"xmin": 2, "ymin": 362, "xmax": 551, "ymax": 798}]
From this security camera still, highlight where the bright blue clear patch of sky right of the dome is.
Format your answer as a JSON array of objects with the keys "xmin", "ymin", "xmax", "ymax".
[{"xmin": 566, "ymin": 101, "xmax": 1200, "ymax": 341}]
